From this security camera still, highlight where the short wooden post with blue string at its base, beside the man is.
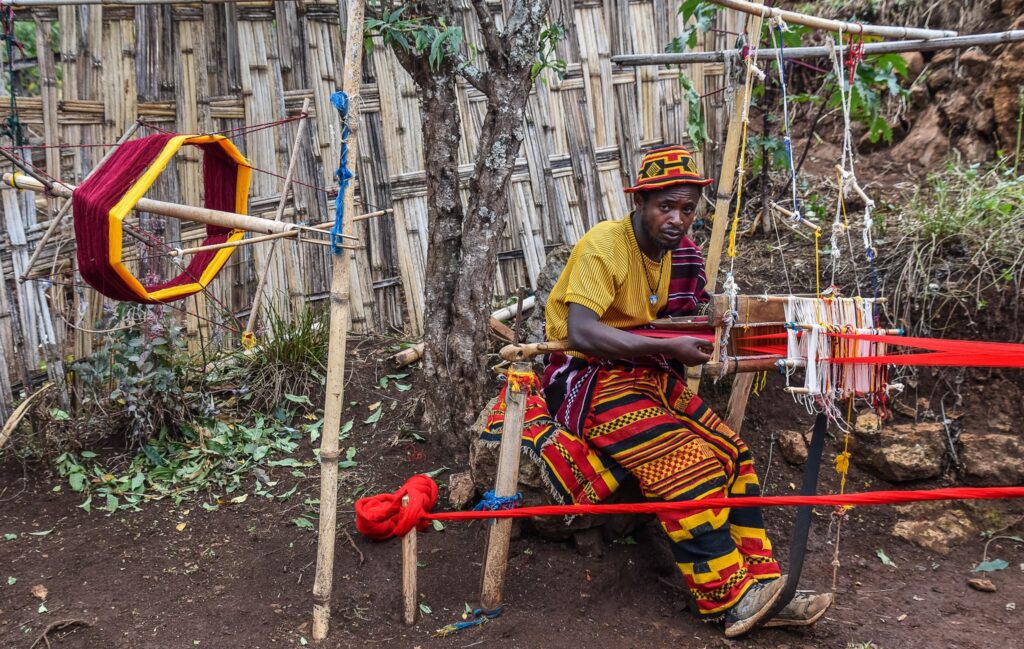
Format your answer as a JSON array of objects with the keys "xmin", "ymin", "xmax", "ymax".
[{"xmin": 480, "ymin": 362, "xmax": 532, "ymax": 611}]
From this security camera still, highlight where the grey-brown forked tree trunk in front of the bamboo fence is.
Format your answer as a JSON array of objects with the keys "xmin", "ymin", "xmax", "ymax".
[{"xmin": 398, "ymin": 0, "xmax": 551, "ymax": 455}]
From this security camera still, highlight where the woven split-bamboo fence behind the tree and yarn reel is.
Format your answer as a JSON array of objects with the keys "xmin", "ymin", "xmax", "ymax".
[{"xmin": 0, "ymin": 0, "xmax": 745, "ymax": 417}]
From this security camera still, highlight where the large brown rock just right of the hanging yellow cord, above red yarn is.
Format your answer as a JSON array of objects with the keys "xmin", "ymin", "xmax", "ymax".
[{"xmin": 852, "ymin": 423, "xmax": 946, "ymax": 482}]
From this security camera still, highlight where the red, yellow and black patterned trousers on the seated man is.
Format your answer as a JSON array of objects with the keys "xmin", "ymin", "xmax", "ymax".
[{"xmin": 584, "ymin": 367, "xmax": 779, "ymax": 619}]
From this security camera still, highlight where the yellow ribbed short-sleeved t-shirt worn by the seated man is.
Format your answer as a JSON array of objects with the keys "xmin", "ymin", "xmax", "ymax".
[{"xmin": 544, "ymin": 216, "xmax": 672, "ymax": 340}]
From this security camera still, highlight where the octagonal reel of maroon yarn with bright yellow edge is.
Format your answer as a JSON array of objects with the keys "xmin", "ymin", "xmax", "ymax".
[{"xmin": 72, "ymin": 133, "xmax": 252, "ymax": 304}]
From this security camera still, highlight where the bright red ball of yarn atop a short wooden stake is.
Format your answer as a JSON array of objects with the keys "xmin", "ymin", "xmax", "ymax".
[{"xmin": 355, "ymin": 474, "xmax": 437, "ymax": 540}]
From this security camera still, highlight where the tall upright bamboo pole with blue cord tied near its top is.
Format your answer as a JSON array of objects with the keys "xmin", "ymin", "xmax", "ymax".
[{"xmin": 312, "ymin": 0, "xmax": 364, "ymax": 642}]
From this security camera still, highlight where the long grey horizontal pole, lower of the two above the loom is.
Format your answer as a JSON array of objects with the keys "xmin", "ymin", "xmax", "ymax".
[{"xmin": 611, "ymin": 30, "xmax": 1024, "ymax": 67}]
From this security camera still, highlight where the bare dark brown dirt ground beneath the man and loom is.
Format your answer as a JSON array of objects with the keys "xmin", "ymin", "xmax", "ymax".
[{"xmin": 0, "ymin": 348, "xmax": 1024, "ymax": 649}]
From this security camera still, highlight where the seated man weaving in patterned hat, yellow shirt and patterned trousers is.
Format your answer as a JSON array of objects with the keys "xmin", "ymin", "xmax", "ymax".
[{"xmin": 543, "ymin": 145, "xmax": 831, "ymax": 638}]
